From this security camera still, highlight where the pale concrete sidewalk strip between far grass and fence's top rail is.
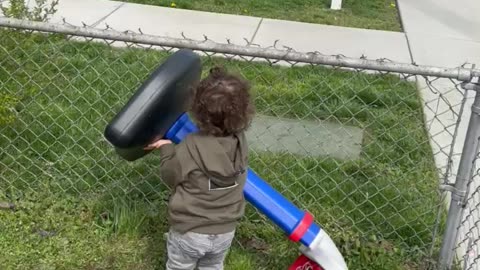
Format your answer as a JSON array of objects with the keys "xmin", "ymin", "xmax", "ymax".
[{"xmin": 46, "ymin": 0, "xmax": 412, "ymax": 63}]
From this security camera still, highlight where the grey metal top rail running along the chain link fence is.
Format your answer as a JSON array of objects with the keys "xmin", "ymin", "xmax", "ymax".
[{"xmin": 0, "ymin": 17, "xmax": 480, "ymax": 81}]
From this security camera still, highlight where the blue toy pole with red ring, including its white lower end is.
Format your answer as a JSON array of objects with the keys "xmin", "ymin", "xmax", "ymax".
[{"xmin": 165, "ymin": 114, "xmax": 347, "ymax": 270}]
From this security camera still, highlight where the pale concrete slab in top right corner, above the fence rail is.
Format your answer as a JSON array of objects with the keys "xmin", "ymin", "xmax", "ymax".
[{"xmin": 398, "ymin": 0, "xmax": 480, "ymax": 66}]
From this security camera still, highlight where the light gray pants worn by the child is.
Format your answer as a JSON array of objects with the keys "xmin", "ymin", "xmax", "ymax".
[{"xmin": 166, "ymin": 230, "xmax": 235, "ymax": 270}]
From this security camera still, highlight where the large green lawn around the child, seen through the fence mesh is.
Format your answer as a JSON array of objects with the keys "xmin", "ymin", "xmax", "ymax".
[{"xmin": 0, "ymin": 32, "xmax": 440, "ymax": 269}]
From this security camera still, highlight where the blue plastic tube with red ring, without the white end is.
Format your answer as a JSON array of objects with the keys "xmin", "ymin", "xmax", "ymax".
[{"xmin": 165, "ymin": 113, "xmax": 320, "ymax": 247}]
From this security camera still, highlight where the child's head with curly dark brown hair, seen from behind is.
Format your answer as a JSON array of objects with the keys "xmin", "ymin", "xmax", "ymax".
[{"xmin": 191, "ymin": 67, "xmax": 254, "ymax": 136}]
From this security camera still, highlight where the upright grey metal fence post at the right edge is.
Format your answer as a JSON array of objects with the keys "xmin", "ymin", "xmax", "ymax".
[{"xmin": 439, "ymin": 83, "xmax": 480, "ymax": 270}]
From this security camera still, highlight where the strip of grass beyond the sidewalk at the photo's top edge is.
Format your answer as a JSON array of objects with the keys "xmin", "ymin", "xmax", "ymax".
[{"xmin": 122, "ymin": 0, "xmax": 402, "ymax": 31}]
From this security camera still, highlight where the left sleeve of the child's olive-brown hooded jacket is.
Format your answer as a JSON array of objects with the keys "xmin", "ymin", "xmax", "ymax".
[{"xmin": 159, "ymin": 144, "xmax": 182, "ymax": 188}]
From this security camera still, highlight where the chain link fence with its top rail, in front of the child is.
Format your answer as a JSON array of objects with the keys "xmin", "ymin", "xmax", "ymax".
[{"xmin": 0, "ymin": 19, "xmax": 479, "ymax": 269}]
